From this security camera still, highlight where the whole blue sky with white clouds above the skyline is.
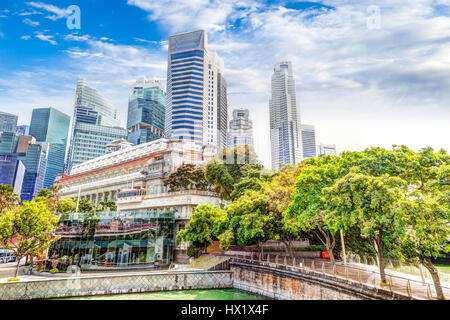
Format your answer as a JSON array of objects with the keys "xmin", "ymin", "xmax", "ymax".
[{"xmin": 0, "ymin": 0, "xmax": 450, "ymax": 169}]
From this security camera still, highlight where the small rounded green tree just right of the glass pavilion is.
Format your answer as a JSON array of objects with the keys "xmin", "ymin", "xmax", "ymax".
[{"xmin": 176, "ymin": 205, "xmax": 225, "ymax": 251}]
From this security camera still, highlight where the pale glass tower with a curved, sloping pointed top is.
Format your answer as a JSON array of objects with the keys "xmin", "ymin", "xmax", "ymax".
[{"xmin": 66, "ymin": 80, "xmax": 127, "ymax": 172}]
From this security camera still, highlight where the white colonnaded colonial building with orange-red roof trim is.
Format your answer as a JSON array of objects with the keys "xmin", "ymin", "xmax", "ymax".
[{"xmin": 56, "ymin": 139, "xmax": 222, "ymax": 261}]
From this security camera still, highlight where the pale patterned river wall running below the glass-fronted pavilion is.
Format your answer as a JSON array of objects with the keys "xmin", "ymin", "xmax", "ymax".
[{"xmin": 0, "ymin": 271, "xmax": 233, "ymax": 299}]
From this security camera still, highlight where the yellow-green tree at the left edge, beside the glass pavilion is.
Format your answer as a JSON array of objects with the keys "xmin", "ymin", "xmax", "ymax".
[{"xmin": 0, "ymin": 200, "xmax": 58, "ymax": 277}]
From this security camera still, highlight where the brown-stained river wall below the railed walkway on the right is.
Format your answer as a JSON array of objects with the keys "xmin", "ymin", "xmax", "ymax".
[{"xmin": 230, "ymin": 261, "xmax": 409, "ymax": 300}]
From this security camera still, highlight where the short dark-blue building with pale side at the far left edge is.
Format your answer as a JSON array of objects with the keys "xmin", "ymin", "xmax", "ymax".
[{"xmin": 0, "ymin": 153, "xmax": 25, "ymax": 195}]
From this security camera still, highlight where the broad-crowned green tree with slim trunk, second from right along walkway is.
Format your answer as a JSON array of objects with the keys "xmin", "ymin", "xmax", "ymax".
[{"xmin": 323, "ymin": 173, "xmax": 407, "ymax": 284}]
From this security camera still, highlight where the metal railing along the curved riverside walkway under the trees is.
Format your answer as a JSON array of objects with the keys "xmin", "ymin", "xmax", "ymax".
[{"xmin": 232, "ymin": 253, "xmax": 450, "ymax": 299}]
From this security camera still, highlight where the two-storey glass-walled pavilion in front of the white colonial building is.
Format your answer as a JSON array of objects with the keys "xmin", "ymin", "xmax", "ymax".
[{"xmin": 48, "ymin": 210, "xmax": 175, "ymax": 269}]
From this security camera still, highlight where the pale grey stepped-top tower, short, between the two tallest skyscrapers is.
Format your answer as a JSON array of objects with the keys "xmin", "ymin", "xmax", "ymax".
[{"xmin": 227, "ymin": 109, "xmax": 253, "ymax": 148}]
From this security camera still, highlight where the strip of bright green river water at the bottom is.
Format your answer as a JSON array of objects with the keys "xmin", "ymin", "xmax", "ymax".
[{"xmin": 60, "ymin": 289, "xmax": 268, "ymax": 300}]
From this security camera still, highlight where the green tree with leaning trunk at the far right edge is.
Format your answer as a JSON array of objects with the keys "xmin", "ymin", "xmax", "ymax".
[{"xmin": 399, "ymin": 196, "xmax": 450, "ymax": 300}]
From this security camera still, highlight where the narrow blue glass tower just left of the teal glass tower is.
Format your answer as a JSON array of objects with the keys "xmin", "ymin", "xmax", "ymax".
[{"xmin": 17, "ymin": 136, "xmax": 49, "ymax": 201}]
